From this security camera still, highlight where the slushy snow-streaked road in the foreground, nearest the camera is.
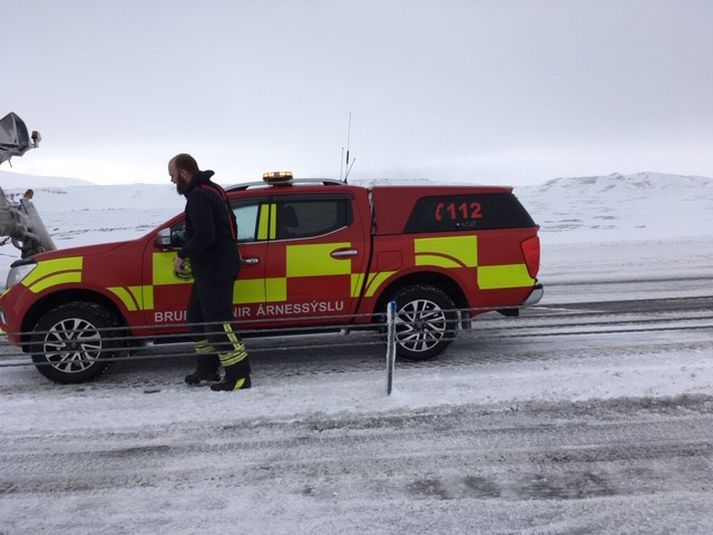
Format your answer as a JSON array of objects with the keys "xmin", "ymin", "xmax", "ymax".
[{"xmin": 2, "ymin": 396, "xmax": 713, "ymax": 533}]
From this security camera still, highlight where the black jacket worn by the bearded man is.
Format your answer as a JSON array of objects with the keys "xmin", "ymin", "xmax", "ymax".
[{"xmin": 178, "ymin": 171, "xmax": 240, "ymax": 282}]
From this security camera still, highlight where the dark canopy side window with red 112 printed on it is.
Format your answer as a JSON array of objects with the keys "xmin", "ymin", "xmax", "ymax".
[{"xmin": 405, "ymin": 193, "xmax": 535, "ymax": 233}]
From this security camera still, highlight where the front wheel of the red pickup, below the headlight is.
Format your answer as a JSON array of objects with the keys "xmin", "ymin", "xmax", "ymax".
[{"xmin": 30, "ymin": 301, "xmax": 125, "ymax": 384}]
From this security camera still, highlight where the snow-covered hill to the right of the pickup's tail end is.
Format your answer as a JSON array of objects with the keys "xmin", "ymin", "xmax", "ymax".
[{"xmin": 515, "ymin": 173, "xmax": 713, "ymax": 243}]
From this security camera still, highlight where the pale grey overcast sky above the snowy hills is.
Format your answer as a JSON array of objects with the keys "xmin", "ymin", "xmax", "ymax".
[{"xmin": 0, "ymin": 0, "xmax": 713, "ymax": 185}]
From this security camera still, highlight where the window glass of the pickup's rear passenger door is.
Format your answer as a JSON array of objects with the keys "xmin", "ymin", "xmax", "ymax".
[{"xmin": 275, "ymin": 195, "xmax": 353, "ymax": 240}]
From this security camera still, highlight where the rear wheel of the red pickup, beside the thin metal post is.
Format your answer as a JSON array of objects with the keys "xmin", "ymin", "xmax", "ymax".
[{"xmin": 389, "ymin": 284, "xmax": 458, "ymax": 360}]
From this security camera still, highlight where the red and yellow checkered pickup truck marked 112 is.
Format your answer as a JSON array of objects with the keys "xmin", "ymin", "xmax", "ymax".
[{"xmin": 0, "ymin": 179, "xmax": 543, "ymax": 383}]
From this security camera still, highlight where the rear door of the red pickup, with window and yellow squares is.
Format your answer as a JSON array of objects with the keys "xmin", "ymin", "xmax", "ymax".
[{"xmin": 258, "ymin": 192, "xmax": 369, "ymax": 326}]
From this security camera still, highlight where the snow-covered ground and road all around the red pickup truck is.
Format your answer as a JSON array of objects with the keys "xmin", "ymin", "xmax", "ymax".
[{"xmin": 0, "ymin": 174, "xmax": 713, "ymax": 534}]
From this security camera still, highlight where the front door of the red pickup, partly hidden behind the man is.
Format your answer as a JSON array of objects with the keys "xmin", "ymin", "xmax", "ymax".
[{"xmin": 144, "ymin": 197, "xmax": 270, "ymax": 328}]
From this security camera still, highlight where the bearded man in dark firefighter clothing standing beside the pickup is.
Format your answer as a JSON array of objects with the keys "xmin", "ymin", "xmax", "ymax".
[{"xmin": 168, "ymin": 154, "xmax": 250, "ymax": 391}]
